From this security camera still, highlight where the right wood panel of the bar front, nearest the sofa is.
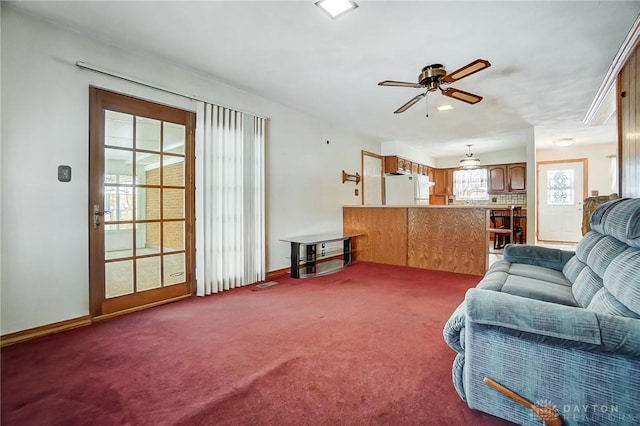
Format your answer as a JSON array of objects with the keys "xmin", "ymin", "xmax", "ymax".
[{"xmin": 407, "ymin": 208, "xmax": 488, "ymax": 275}]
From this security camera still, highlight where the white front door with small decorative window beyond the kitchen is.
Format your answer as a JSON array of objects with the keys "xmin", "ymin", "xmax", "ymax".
[{"xmin": 538, "ymin": 159, "xmax": 587, "ymax": 243}]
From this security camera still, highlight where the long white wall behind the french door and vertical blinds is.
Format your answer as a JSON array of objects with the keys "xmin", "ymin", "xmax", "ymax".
[{"xmin": 0, "ymin": 3, "xmax": 380, "ymax": 334}]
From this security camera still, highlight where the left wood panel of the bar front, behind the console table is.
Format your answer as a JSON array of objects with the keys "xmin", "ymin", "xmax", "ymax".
[{"xmin": 342, "ymin": 207, "xmax": 407, "ymax": 266}]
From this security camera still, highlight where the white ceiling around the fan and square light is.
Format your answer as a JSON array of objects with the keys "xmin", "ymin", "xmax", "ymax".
[{"xmin": 12, "ymin": 0, "xmax": 640, "ymax": 157}]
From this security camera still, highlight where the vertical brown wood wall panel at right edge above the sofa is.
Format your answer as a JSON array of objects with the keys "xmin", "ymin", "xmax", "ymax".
[{"xmin": 617, "ymin": 42, "xmax": 640, "ymax": 197}]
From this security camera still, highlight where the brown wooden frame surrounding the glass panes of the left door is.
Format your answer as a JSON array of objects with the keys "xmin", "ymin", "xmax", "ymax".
[{"xmin": 87, "ymin": 86, "xmax": 196, "ymax": 321}]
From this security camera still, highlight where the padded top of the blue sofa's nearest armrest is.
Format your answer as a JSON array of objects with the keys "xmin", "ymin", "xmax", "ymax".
[{"xmin": 465, "ymin": 288, "xmax": 640, "ymax": 358}]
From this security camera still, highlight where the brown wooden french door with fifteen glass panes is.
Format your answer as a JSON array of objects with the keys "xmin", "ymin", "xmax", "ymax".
[{"xmin": 89, "ymin": 87, "xmax": 195, "ymax": 317}]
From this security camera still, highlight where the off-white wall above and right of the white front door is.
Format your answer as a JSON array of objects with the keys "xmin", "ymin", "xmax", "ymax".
[{"xmin": 536, "ymin": 141, "xmax": 618, "ymax": 196}]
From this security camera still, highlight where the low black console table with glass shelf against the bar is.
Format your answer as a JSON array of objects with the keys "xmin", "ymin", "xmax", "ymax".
[{"xmin": 281, "ymin": 233, "xmax": 360, "ymax": 278}]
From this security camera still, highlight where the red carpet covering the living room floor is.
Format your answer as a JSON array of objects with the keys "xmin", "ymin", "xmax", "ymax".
[{"xmin": 1, "ymin": 263, "xmax": 510, "ymax": 426}]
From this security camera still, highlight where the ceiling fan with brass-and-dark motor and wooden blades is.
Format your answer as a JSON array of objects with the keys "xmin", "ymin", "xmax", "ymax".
[{"xmin": 378, "ymin": 59, "xmax": 491, "ymax": 114}]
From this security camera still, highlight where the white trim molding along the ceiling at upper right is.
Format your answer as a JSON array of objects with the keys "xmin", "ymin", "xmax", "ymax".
[{"xmin": 582, "ymin": 16, "xmax": 640, "ymax": 126}]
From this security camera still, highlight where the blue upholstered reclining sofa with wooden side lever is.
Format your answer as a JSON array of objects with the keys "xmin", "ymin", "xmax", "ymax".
[{"xmin": 444, "ymin": 199, "xmax": 640, "ymax": 425}]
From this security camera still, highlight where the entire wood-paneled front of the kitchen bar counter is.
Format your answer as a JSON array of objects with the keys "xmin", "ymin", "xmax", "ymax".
[{"xmin": 343, "ymin": 206, "xmax": 489, "ymax": 276}]
